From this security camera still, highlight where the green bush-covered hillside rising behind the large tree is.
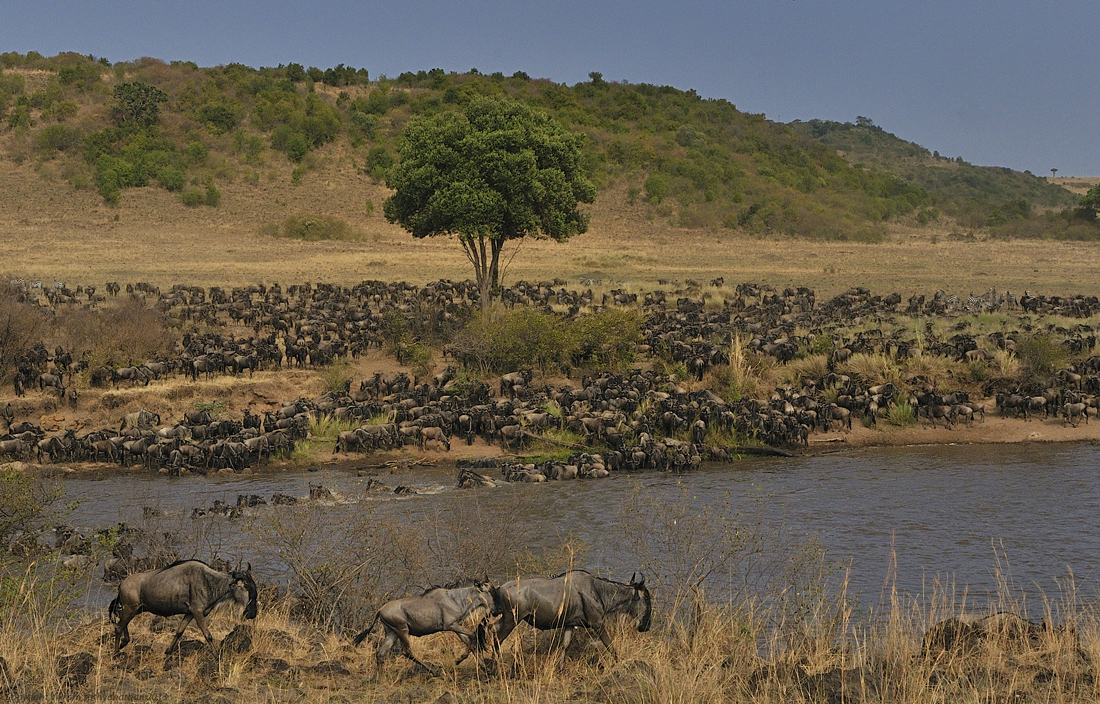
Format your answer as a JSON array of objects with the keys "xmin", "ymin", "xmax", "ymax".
[{"xmin": 0, "ymin": 52, "xmax": 1091, "ymax": 241}]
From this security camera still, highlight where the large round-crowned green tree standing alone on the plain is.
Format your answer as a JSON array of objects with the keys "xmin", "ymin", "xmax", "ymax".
[{"xmin": 384, "ymin": 98, "xmax": 596, "ymax": 301}]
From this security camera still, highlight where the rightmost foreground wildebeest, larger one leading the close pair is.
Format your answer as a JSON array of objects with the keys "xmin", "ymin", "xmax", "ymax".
[{"xmin": 494, "ymin": 570, "xmax": 652, "ymax": 655}]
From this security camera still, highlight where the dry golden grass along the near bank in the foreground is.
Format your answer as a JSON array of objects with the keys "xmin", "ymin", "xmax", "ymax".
[{"xmin": 0, "ymin": 567, "xmax": 1100, "ymax": 704}]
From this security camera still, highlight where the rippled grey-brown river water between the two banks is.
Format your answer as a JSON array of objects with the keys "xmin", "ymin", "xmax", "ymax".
[{"xmin": 63, "ymin": 443, "xmax": 1100, "ymax": 603}]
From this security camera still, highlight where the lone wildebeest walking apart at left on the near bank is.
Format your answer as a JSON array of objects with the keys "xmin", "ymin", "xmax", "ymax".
[{"xmin": 107, "ymin": 560, "xmax": 257, "ymax": 652}]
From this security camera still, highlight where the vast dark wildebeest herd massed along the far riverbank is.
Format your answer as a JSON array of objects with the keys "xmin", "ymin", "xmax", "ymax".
[{"xmin": 0, "ymin": 279, "xmax": 1100, "ymax": 483}]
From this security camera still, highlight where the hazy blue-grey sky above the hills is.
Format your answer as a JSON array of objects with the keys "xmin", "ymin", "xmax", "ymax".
[{"xmin": 0, "ymin": 0, "xmax": 1100, "ymax": 176}]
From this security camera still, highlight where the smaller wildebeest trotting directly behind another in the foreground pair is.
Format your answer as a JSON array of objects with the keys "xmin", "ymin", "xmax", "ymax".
[{"xmin": 353, "ymin": 582, "xmax": 494, "ymax": 672}]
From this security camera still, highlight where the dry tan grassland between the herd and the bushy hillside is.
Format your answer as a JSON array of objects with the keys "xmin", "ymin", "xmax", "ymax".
[{"xmin": 0, "ymin": 158, "xmax": 1100, "ymax": 296}]
